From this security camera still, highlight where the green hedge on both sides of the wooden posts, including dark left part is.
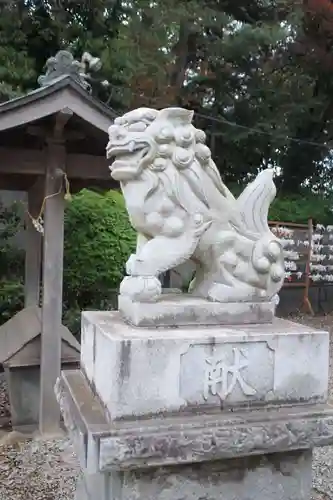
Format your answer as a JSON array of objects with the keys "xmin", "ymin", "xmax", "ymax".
[{"xmin": 0, "ymin": 190, "xmax": 135, "ymax": 333}]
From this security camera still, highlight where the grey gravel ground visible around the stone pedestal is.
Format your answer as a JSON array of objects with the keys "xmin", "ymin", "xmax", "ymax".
[{"xmin": 0, "ymin": 315, "xmax": 333, "ymax": 500}]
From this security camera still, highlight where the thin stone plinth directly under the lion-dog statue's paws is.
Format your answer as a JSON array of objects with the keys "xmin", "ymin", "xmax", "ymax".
[{"xmin": 118, "ymin": 294, "xmax": 275, "ymax": 328}]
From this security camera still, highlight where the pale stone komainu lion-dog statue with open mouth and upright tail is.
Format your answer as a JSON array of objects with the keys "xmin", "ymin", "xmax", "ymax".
[{"xmin": 107, "ymin": 108, "xmax": 284, "ymax": 302}]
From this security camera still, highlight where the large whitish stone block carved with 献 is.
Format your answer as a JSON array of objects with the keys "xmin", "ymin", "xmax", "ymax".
[{"xmin": 81, "ymin": 312, "xmax": 329, "ymax": 421}]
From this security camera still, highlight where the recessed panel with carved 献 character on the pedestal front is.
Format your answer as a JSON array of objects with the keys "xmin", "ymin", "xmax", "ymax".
[{"xmin": 179, "ymin": 341, "xmax": 275, "ymax": 407}]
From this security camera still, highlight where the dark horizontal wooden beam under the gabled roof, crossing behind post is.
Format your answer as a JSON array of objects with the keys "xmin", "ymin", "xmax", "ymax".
[{"xmin": 0, "ymin": 148, "xmax": 110, "ymax": 180}]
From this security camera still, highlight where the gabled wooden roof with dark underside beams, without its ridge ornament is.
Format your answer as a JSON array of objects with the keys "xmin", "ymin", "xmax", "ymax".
[{"xmin": 0, "ymin": 75, "xmax": 115, "ymax": 191}]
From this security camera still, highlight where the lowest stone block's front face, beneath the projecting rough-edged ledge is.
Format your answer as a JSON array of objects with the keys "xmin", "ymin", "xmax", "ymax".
[{"xmin": 116, "ymin": 452, "xmax": 311, "ymax": 500}]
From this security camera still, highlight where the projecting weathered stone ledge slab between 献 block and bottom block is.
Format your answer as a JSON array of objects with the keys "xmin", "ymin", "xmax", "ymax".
[{"xmin": 57, "ymin": 370, "xmax": 333, "ymax": 474}]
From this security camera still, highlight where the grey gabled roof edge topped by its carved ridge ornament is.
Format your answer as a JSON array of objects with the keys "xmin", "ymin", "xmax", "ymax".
[{"xmin": 0, "ymin": 50, "xmax": 116, "ymax": 136}]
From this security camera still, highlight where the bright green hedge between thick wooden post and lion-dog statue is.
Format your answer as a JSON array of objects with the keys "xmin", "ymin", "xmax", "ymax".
[{"xmin": 64, "ymin": 190, "xmax": 136, "ymax": 330}]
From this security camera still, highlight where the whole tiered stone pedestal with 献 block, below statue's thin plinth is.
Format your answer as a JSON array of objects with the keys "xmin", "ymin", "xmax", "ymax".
[{"xmin": 56, "ymin": 312, "xmax": 333, "ymax": 500}]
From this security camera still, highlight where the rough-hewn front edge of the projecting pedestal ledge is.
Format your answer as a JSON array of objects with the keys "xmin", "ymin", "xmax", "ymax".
[{"xmin": 100, "ymin": 408, "xmax": 333, "ymax": 470}]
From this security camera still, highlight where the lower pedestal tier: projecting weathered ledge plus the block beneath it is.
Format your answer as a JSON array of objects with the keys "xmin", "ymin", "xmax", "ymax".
[{"xmin": 56, "ymin": 370, "xmax": 333, "ymax": 500}]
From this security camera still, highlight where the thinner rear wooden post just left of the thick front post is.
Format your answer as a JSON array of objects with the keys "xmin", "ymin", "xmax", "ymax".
[{"xmin": 24, "ymin": 186, "xmax": 42, "ymax": 307}]
